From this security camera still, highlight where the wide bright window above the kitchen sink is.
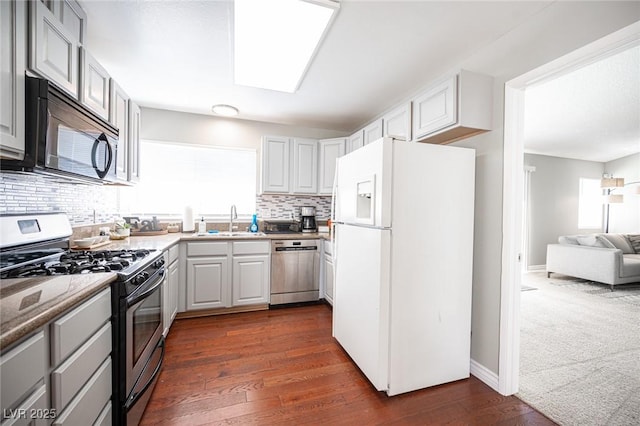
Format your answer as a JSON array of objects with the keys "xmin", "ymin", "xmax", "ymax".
[{"xmin": 120, "ymin": 140, "xmax": 256, "ymax": 218}]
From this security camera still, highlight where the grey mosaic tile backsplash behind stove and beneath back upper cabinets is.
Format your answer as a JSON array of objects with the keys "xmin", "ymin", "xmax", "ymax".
[{"xmin": 0, "ymin": 171, "xmax": 331, "ymax": 227}]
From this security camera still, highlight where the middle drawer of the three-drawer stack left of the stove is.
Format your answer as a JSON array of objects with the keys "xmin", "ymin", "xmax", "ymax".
[{"xmin": 51, "ymin": 323, "xmax": 111, "ymax": 412}]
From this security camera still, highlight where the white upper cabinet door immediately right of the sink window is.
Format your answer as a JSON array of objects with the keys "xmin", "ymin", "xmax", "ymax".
[{"xmin": 262, "ymin": 136, "xmax": 290, "ymax": 193}]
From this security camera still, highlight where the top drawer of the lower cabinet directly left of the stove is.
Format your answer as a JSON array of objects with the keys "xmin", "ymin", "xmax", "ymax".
[{"xmin": 51, "ymin": 289, "xmax": 111, "ymax": 367}]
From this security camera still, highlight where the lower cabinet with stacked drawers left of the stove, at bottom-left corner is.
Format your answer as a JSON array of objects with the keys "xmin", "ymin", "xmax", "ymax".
[{"xmin": 0, "ymin": 288, "xmax": 112, "ymax": 426}]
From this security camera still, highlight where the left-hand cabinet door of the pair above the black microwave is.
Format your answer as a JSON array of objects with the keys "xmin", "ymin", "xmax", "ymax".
[{"xmin": 29, "ymin": 1, "xmax": 80, "ymax": 99}]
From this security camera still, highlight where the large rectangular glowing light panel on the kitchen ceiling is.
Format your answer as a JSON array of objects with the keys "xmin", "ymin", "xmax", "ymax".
[{"xmin": 234, "ymin": 0, "xmax": 340, "ymax": 93}]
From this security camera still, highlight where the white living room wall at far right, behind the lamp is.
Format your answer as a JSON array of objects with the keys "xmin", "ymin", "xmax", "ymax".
[{"xmin": 604, "ymin": 153, "xmax": 640, "ymax": 234}]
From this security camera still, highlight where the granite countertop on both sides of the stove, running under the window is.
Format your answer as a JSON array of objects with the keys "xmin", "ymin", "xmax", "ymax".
[{"xmin": 0, "ymin": 232, "xmax": 331, "ymax": 349}]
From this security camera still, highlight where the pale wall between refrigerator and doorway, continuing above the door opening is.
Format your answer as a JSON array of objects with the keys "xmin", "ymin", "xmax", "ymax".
[{"xmin": 440, "ymin": 2, "xmax": 640, "ymax": 375}]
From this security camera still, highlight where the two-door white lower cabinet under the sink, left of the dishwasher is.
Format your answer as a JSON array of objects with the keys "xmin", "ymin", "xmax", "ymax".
[{"xmin": 182, "ymin": 240, "xmax": 271, "ymax": 311}]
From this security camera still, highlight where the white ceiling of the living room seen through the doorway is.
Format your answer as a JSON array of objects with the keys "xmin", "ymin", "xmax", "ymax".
[{"xmin": 524, "ymin": 46, "xmax": 640, "ymax": 162}]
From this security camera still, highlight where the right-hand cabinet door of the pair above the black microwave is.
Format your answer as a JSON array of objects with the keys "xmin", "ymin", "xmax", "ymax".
[{"xmin": 80, "ymin": 48, "xmax": 110, "ymax": 120}]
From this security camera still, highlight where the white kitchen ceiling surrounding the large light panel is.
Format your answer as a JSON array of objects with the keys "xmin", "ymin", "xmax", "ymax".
[{"xmin": 80, "ymin": 0, "xmax": 637, "ymax": 163}]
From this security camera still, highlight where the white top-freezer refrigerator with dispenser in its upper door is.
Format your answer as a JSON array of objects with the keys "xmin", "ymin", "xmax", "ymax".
[{"xmin": 333, "ymin": 138, "xmax": 475, "ymax": 396}]
